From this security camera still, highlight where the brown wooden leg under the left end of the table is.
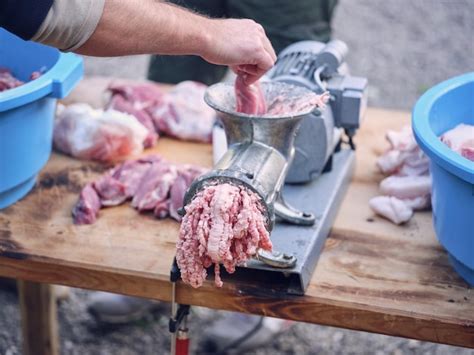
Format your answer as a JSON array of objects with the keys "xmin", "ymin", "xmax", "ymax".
[{"xmin": 18, "ymin": 280, "xmax": 59, "ymax": 355}]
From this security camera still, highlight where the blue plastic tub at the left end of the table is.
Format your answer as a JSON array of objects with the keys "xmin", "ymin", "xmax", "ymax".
[{"xmin": 0, "ymin": 28, "xmax": 83, "ymax": 209}]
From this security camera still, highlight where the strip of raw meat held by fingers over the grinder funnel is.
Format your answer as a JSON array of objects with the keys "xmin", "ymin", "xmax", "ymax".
[{"xmin": 235, "ymin": 75, "xmax": 267, "ymax": 115}]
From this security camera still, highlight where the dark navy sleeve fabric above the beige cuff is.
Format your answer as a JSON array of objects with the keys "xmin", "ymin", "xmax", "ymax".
[{"xmin": 0, "ymin": 0, "xmax": 54, "ymax": 40}]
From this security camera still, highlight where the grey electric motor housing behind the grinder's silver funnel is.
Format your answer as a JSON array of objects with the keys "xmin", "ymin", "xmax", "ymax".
[{"xmin": 266, "ymin": 40, "xmax": 367, "ymax": 183}]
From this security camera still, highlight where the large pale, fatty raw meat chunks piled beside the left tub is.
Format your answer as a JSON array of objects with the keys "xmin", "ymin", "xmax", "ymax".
[{"xmin": 54, "ymin": 81, "xmax": 215, "ymax": 162}]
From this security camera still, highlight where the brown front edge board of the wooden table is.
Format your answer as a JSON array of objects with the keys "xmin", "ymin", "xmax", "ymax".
[{"xmin": 0, "ymin": 257, "xmax": 474, "ymax": 348}]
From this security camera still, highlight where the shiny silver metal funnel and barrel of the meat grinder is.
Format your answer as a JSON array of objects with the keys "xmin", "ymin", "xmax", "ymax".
[{"xmin": 182, "ymin": 82, "xmax": 322, "ymax": 231}]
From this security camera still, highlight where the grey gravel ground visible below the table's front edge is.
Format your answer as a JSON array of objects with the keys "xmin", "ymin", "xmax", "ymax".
[{"xmin": 0, "ymin": 289, "xmax": 474, "ymax": 355}]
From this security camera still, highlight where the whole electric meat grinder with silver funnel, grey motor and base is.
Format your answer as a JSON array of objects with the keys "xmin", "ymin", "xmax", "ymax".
[{"xmin": 184, "ymin": 41, "xmax": 367, "ymax": 294}]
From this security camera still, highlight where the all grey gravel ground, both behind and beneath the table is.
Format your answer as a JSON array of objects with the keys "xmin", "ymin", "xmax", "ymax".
[{"xmin": 0, "ymin": 0, "xmax": 474, "ymax": 355}]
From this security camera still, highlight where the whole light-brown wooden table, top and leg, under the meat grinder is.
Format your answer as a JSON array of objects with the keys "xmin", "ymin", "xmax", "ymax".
[{"xmin": 0, "ymin": 101, "xmax": 474, "ymax": 354}]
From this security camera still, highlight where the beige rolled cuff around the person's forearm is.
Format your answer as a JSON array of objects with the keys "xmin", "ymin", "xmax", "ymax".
[{"xmin": 31, "ymin": 0, "xmax": 105, "ymax": 51}]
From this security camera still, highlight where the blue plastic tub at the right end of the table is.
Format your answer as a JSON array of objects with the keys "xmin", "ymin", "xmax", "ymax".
[{"xmin": 412, "ymin": 72, "xmax": 474, "ymax": 285}]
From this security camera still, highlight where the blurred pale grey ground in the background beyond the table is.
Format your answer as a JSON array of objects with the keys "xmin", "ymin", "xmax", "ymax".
[{"xmin": 85, "ymin": 0, "xmax": 474, "ymax": 110}]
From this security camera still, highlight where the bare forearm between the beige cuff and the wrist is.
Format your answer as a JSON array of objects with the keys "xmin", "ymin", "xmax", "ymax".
[{"xmin": 76, "ymin": 0, "xmax": 211, "ymax": 56}]
